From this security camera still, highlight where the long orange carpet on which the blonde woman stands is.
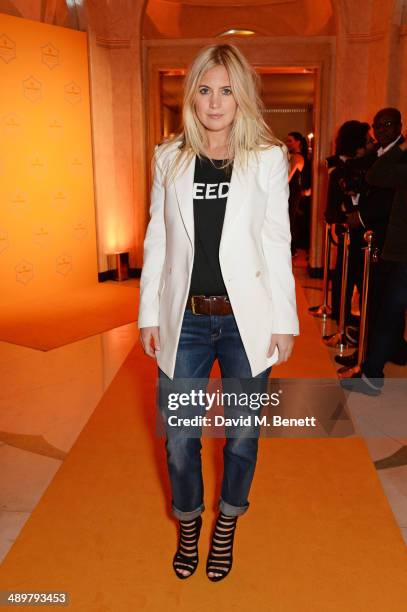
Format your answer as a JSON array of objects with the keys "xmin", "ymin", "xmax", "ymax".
[{"xmin": 0, "ymin": 284, "xmax": 407, "ymax": 612}]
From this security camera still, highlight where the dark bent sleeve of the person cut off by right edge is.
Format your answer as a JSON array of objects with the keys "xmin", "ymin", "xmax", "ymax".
[{"xmin": 366, "ymin": 146, "xmax": 407, "ymax": 189}]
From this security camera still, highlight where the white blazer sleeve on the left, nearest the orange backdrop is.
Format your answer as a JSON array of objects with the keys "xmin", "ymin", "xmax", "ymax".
[{"xmin": 138, "ymin": 147, "xmax": 166, "ymax": 328}]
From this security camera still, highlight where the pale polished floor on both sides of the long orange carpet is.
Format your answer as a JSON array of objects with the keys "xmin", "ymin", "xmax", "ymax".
[{"xmin": 0, "ymin": 267, "xmax": 407, "ymax": 559}]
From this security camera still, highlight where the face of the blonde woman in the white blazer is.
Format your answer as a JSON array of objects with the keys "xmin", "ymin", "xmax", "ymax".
[{"xmin": 195, "ymin": 66, "xmax": 237, "ymax": 134}]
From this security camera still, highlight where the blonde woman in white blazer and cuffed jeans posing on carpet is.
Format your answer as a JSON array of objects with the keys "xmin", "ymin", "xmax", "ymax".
[{"xmin": 138, "ymin": 45, "xmax": 298, "ymax": 581}]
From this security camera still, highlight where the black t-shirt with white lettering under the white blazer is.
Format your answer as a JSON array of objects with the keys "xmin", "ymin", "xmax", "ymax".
[{"xmin": 189, "ymin": 157, "xmax": 232, "ymax": 295}]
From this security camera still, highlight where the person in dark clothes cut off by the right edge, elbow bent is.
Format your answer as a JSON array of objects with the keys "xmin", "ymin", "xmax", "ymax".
[{"xmin": 342, "ymin": 133, "xmax": 407, "ymax": 395}]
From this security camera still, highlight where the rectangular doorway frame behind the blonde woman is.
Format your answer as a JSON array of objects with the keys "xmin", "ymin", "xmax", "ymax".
[{"xmin": 142, "ymin": 36, "xmax": 336, "ymax": 276}]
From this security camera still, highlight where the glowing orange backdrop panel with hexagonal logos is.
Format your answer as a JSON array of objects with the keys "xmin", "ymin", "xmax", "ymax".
[{"xmin": 0, "ymin": 15, "xmax": 97, "ymax": 304}]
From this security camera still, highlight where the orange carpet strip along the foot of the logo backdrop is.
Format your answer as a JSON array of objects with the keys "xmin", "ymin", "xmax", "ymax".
[{"xmin": 0, "ymin": 280, "xmax": 139, "ymax": 351}]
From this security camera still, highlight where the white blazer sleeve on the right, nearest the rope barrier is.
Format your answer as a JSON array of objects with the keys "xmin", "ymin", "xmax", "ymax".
[{"xmin": 263, "ymin": 146, "xmax": 299, "ymax": 335}]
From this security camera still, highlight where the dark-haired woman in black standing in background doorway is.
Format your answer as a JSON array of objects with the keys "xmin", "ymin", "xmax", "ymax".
[{"xmin": 285, "ymin": 132, "xmax": 309, "ymax": 255}]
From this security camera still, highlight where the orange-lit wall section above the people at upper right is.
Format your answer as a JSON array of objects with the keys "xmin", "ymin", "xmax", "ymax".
[{"xmin": 333, "ymin": 0, "xmax": 407, "ymax": 126}]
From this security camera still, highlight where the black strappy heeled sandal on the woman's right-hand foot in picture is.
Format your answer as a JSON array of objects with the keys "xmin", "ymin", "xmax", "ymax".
[{"xmin": 206, "ymin": 512, "xmax": 237, "ymax": 582}]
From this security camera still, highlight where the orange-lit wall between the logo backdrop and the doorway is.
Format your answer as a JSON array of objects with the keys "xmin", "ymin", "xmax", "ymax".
[{"xmin": 86, "ymin": 0, "xmax": 147, "ymax": 272}]
